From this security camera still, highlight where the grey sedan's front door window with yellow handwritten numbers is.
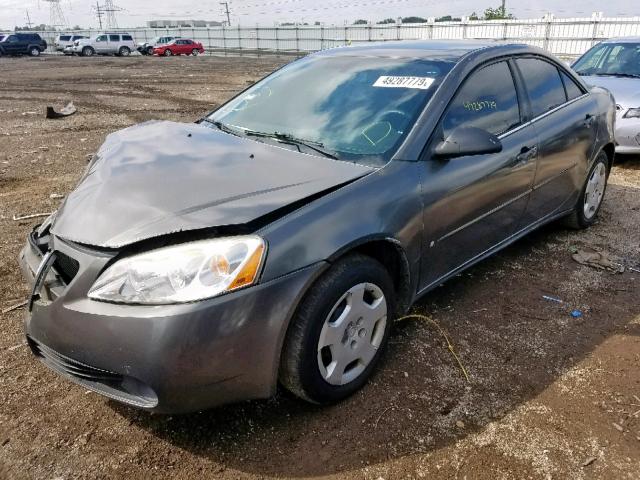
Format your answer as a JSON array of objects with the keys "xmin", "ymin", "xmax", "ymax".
[{"xmin": 443, "ymin": 62, "xmax": 520, "ymax": 136}]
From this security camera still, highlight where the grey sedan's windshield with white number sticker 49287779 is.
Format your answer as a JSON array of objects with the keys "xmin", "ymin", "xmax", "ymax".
[{"xmin": 206, "ymin": 56, "xmax": 454, "ymax": 165}]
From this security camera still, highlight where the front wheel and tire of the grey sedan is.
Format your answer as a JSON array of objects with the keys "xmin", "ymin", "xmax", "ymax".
[{"xmin": 279, "ymin": 254, "xmax": 395, "ymax": 404}]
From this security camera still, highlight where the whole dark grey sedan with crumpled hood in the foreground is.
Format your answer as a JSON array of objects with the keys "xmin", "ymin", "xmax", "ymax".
[{"xmin": 19, "ymin": 41, "xmax": 615, "ymax": 412}]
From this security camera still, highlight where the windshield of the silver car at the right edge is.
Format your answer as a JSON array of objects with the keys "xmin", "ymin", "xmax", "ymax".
[{"xmin": 573, "ymin": 42, "xmax": 640, "ymax": 76}]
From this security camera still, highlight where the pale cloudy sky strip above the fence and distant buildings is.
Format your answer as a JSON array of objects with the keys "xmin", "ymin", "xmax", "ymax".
[{"xmin": 0, "ymin": 0, "xmax": 640, "ymax": 29}]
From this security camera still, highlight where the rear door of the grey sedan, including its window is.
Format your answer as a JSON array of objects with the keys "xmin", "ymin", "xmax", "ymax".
[{"xmin": 515, "ymin": 57, "xmax": 597, "ymax": 224}]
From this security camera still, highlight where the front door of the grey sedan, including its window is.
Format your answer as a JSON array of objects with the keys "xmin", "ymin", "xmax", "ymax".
[{"xmin": 420, "ymin": 60, "xmax": 537, "ymax": 288}]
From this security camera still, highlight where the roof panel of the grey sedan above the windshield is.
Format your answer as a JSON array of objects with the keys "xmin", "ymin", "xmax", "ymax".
[{"xmin": 311, "ymin": 40, "xmax": 540, "ymax": 61}]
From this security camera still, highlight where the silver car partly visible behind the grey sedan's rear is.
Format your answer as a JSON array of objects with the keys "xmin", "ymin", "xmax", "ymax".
[{"xmin": 573, "ymin": 37, "xmax": 640, "ymax": 154}]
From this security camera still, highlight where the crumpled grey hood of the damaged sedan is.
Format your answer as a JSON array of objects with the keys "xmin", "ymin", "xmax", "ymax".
[{"xmin": 51, "ymin": 121, "xmax": 374, "ymax": 248}]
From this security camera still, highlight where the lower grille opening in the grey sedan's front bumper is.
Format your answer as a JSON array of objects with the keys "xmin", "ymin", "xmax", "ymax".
[{"xmin": 27, "ymin": 336, "xmax": 158, "ymax": 408}]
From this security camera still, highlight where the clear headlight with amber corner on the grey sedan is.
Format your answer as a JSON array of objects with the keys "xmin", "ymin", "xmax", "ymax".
[{"xmin": 89, "ymin": 235, "xmax": 265, "ymax": 305}]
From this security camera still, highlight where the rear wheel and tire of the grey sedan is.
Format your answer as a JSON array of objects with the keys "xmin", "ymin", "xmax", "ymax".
[{"xmin": 565, "ymin": 152, "xmax": 609, "ymax": 229}]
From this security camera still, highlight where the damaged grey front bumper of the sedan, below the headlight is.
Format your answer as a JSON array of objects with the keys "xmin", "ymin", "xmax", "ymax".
[{"xmin": 20, "ymin": 232, "xmax": 323, "ymax": 413}]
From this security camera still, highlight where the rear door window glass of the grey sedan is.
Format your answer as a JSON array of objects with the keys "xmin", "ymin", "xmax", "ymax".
[{"xmin": 516, "ymin": 58, "xmax": 567, "ymax": 117}]
